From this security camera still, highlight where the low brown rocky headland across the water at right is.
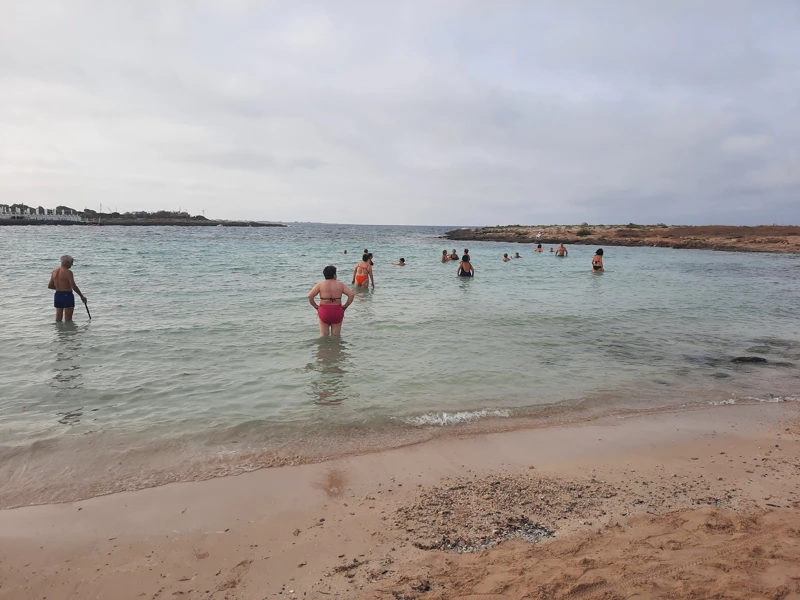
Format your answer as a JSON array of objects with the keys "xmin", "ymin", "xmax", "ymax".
[{"xmin": 444, "ymin": 223, "xmax": 800, "ymax": 254}]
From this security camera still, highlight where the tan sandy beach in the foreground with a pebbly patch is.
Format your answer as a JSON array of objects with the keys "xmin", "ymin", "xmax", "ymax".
[{"xmin": 0, "ymin": 403, "xmax": 800, "ymax": 600}]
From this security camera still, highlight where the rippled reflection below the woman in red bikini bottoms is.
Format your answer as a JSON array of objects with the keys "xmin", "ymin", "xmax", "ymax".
[{"xmin": 306, "ymin": 336, "xmax": 358, "ymax": 406}]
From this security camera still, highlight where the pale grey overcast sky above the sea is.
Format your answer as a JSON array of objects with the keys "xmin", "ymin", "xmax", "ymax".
[{"xmin": 0, "ymin": 0, "xmax": 800, "ymax": 225}]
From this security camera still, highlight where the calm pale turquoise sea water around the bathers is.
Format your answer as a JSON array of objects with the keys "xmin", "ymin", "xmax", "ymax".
[{"xmin": 0, "ymin": 225, "xmax": 800, "ymax": 506}]
